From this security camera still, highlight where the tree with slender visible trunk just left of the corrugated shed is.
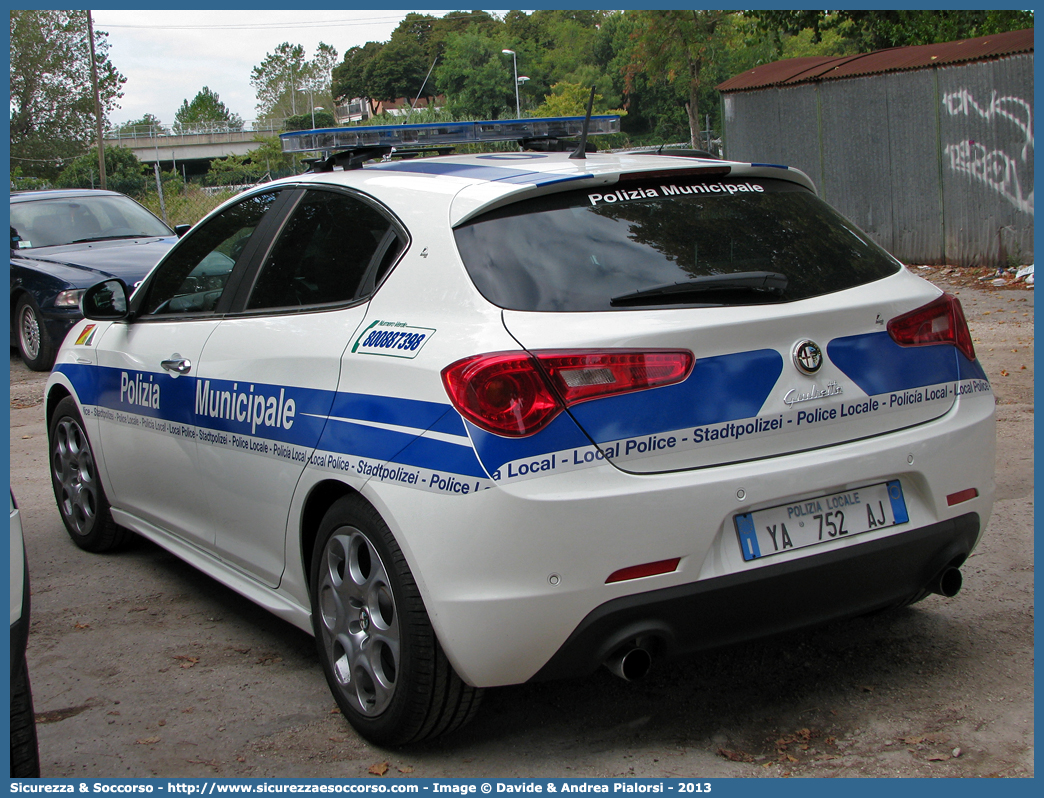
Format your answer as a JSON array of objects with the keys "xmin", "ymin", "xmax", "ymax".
[{"xmin": 626, "ymin": 10, "xmax": 730, "ymax": 147}]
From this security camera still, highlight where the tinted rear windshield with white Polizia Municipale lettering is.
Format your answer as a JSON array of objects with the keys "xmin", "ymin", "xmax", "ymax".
[{"xmin": 454, "ymin": 175, "xmax": 901, "ymax": 311}]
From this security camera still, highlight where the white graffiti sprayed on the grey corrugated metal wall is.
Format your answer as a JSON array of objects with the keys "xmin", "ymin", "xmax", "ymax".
[{"xmin": 943, "ymin": 89, "xmax": 1034, "ymax": 215}]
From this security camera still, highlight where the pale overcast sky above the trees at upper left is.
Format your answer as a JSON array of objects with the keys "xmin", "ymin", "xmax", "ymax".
[{"xmin": 93, "ymin": 9, "xmax": 461, "ymax": 124}]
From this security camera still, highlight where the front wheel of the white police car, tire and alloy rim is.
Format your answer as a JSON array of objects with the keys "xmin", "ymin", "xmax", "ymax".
[{"xmin": 48, "ymin": 396, "xmax": 129, "ymax": 553}]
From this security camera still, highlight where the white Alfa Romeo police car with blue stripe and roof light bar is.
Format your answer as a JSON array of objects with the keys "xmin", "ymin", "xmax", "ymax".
[{"xmin": 47, "ymin": 117, "xmax": 994, "ymax": 744}]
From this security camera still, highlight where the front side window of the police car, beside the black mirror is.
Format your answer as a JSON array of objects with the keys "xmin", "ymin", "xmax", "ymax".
[{"xmin": 140, "ymin": 191, "xmax": 279, "ymax": 315}]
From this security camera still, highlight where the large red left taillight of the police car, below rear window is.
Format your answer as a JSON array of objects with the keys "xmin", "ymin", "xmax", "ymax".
[{"xmin": 443, "ymin": 349, "xmax": 695, "ymax": 438}]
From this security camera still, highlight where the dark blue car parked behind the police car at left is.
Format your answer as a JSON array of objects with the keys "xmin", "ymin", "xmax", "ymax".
[{"xmin": 10, "ymin": 189, "xmax": 188, "ymax": 371}]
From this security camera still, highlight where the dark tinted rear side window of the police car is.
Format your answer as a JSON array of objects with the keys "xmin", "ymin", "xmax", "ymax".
[{"xmin": 246, "ymin": 190, "xmax": 404, "ymax": 310}]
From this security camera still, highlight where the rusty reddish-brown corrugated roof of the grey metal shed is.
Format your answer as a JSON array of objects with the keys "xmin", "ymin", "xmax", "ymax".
[{"xmin": 717, "ymin": 28, "xmax": 1034, "ymax": 92}]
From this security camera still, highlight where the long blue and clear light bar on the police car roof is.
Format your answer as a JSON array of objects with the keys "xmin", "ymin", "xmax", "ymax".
[{"xmin": 279, "ymin": 116, "xmax": 620, "ymax": 152}]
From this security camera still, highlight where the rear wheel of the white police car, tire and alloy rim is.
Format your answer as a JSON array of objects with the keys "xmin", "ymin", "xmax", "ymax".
[{"xmin": 311, "ymin": 495, "xmax": 481, "ymax": 746}]
